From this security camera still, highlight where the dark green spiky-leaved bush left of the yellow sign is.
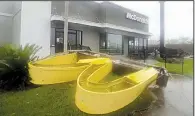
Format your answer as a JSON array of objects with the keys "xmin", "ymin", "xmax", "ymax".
[{"xmin": 0, "ymin": 44, "xmax": 40, "ymax": 90}]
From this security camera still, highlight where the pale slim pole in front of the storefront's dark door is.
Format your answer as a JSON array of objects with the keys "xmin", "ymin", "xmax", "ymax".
[{"xmin": 64, "ymin": 1, "xmax": 69, "ymax": 53}]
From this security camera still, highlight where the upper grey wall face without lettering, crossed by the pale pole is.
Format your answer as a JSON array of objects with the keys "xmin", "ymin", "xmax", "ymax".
[{"xmin": 51, "ymin": 1, "xmax": 100, "ymax": 23}]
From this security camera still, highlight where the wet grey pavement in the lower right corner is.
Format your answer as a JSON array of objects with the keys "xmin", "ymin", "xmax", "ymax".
[{"xmin": 137, "ymin": 75, "xmax": 193, "ymax": 116}]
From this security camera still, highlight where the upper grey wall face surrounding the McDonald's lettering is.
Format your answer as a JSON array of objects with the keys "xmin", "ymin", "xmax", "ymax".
[{"xmin": 101, "ymin": 2, "xmax": 148, "ymax": 32}]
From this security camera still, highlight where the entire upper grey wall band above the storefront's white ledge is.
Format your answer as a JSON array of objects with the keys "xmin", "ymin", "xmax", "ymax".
[{"xmin": 52, "ymin": 1, "xmax": 149, "ymax": 32}]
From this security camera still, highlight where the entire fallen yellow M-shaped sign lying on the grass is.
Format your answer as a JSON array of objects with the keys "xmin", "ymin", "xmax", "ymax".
[{"xmin": 29, "ymin": 54, "xmax": 158, "ymax": 114}]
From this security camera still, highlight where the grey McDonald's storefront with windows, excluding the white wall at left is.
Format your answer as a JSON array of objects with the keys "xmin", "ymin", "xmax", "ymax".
[{"xmin": 51, "ymin": 1, "xmax": 151, "ymax": 56}]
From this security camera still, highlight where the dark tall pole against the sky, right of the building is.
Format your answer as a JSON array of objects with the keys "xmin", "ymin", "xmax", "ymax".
[{"xmin": 160, "ymin": 1, "xmax": 165, "ymax": 58}]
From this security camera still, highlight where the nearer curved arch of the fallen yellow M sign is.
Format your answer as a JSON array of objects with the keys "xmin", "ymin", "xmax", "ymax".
[{"xmin": 75, "ymin": 61, "xmax": 158, "ymax": 114}]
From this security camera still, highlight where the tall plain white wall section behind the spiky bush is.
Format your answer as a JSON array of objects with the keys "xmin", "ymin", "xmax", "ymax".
[{"xmin": 20, "ymin": 1, "xmax": 51, "ymax": 57}]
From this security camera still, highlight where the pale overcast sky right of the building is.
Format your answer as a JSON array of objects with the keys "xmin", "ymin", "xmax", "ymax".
[{"xmin": 95, "ymin": 1, "xmax": 193, "ymax": 39}]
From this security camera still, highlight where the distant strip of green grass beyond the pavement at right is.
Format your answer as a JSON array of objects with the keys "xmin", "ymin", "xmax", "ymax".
[{"xmin": 156, "ymin": 59, "xmax": 194, "ymax": 77}]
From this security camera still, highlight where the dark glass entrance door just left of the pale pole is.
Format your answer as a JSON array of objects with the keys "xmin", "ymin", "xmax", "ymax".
[{"xmin": 55, "ymin": 29, "xmax": 64, "ymax": 53}]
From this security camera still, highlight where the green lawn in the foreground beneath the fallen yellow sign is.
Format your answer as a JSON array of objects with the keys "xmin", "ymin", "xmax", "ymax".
[{"xmin": 0, "ymin": 81, "xmax": 155, "ymax": 116}]
